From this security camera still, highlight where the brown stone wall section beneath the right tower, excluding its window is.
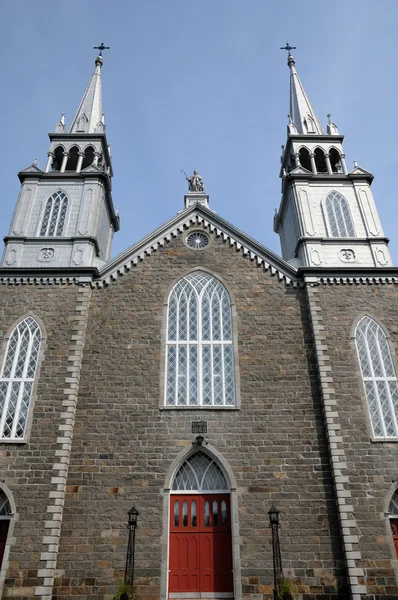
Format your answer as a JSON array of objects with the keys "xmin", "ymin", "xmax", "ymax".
[{"xmin": 317, "ymin": 283, "xmax": 398, "ymax": 597}]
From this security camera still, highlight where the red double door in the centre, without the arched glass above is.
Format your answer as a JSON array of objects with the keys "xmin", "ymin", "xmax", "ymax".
[{"xmin": 169, "ymin": 494, "xmax": 233, "ymax": 597}]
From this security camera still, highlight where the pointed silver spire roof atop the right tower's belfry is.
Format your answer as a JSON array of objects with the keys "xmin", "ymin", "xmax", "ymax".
[{"xmin": 287, "ymin": 52, "xmax": 324, "ymax": 135}]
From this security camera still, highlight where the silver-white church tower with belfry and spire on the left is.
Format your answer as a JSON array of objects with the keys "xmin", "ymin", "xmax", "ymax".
[{"xmin": 1, "ymin": 52, "xmax": 119, "ymax": 269}]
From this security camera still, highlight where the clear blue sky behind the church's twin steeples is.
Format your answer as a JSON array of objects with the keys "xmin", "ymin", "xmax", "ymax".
[{"xmin": 0, "ymin": 0, "xmax": 398, "ymax": 265}]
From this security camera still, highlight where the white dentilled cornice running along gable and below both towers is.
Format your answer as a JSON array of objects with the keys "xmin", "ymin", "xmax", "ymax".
[{"xmin": 0, "ymin": 205, "xmax": 398, "ymax": 287}]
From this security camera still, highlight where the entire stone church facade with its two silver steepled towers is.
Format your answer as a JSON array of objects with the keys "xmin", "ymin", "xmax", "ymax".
[{"xmin": 0, "ymin": 48, "xmax": 398, "ymax": 600}]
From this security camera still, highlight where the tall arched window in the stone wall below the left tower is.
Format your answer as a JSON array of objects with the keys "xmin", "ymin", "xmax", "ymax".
[{"xmin": 0, "ymin": 317, "xmax": 41, "ymax": 440}]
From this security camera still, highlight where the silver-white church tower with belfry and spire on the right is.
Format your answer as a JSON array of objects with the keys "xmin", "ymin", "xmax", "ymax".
[{"xmin": 274, "ymin": 45, "xmax": 392, "ymax": 268}]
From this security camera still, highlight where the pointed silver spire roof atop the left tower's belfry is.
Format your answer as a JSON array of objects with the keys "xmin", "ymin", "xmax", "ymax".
[{"xmin": 69, "ymin": 53, "xmax": 104, "ymax": 133}]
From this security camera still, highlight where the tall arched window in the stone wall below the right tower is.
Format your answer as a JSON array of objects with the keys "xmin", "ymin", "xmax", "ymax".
[{"xmin": 355, "ymin": 315, "xmax": 398, "ymax": 438}]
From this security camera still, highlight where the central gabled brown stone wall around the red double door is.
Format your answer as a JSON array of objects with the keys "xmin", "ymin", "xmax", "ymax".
[{"xmin": 55, "ymin": 236, "xmax": 345, "ymax": 600}]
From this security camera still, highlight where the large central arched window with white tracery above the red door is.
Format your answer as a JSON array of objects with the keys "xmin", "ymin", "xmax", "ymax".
[{"xmin": 165, "ymin": 271, "xmax": 235, "ymax": 406}]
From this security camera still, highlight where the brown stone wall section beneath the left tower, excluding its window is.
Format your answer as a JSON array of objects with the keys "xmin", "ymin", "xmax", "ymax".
[{"xmin": 0, "ymin": 284, "xmax": 78, "ymax": 598}]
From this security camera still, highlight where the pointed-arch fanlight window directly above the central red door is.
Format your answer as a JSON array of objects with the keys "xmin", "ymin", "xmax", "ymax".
[{"xmin": 173, "ymin": 451, "xmax": 229, "ymax": 492}]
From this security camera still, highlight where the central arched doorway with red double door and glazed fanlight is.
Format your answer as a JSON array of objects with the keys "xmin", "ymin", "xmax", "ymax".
[{"xmin": 169, "ymin": 450, "xmax": 233, "ymax": 598}]
